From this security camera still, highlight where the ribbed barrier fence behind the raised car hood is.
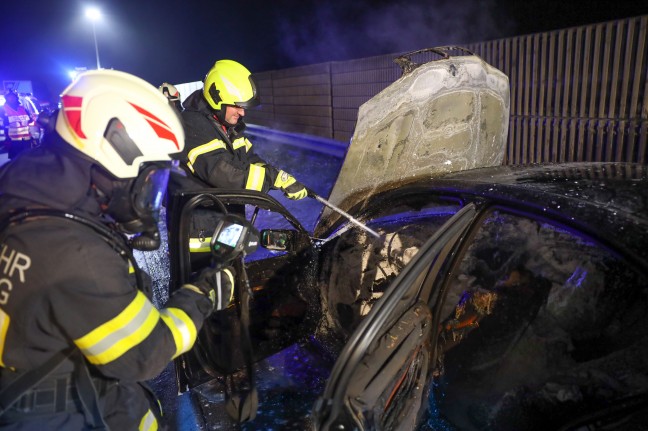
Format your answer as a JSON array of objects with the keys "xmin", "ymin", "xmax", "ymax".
[{"xmin": 248, "ymin": 15, "xmax": 648, "ymax": 164}]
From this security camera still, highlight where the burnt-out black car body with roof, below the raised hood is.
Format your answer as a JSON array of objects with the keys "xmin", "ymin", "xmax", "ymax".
[{"xmin": 308, "ymin": 164, "xmax": 648, "ymax": 430}]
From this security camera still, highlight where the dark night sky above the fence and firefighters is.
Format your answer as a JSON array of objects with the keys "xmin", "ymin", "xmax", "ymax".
[{"xmin": 0, "ymin": 0, "xmax": 648, "ymax": 102}]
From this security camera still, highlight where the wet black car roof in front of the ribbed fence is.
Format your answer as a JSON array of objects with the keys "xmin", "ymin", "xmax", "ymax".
[{"xmin": 426, "ymin": 162, "xmax": 648, "ymax": 269}]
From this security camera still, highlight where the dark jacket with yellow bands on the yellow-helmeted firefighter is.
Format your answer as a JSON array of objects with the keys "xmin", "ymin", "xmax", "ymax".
[{"xmin": 171, "ymin": 90, "xmax": 279, "ymax": 192}]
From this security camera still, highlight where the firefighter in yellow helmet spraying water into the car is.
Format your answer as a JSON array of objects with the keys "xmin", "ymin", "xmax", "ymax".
[{"xmin": 172, "ymin": 60, "xmax": 307, "ymax": 200}]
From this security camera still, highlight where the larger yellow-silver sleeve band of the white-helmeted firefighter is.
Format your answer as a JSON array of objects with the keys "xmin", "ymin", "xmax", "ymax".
[{"xmin": 74, "ymin": 291, "xmax": 160, "ymax": 365}]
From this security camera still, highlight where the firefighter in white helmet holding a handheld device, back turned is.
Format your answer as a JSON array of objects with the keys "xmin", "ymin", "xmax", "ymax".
[{"xmin": 0, "ymin": 69, "xmax": 233, "ymax": 430}]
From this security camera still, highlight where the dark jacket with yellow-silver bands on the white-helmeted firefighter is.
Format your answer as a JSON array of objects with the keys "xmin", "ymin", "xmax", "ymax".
[{"xmin": 0, "ymin": 138, "xmax": 215, "ymax": 430}]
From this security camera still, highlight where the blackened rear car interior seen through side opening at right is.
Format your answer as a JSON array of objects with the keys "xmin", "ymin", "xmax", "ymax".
[{"xmin": 432, "ymin": 209, "xmax": 648, "ymax": 430}]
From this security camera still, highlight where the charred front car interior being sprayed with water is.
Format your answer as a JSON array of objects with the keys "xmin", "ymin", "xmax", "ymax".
[{"xmin": 320, "ymin": 190, "xmax": 461, "ymax": 341}]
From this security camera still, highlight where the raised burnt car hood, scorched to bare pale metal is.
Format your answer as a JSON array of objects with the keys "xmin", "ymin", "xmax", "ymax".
[{"xmin": 314, "ymin": 48, "xmax": 509, "ymax": 236}]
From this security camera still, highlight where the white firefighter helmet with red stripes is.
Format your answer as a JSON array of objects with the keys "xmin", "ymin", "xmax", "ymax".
[{"xmin": 56, "ymin": 69, "xmax": 184, "ymax": 178}]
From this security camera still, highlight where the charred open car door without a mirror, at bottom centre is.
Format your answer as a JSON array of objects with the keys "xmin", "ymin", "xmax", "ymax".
[{"xmin": 314, "ymin": 201, "xmax": 475, "ymax": 429}]
